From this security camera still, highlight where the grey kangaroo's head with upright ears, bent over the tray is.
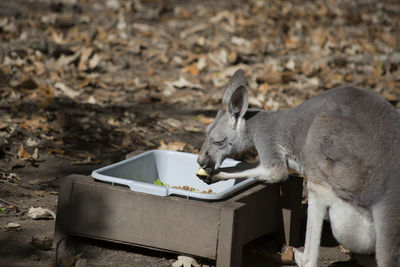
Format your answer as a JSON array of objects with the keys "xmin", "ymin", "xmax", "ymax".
[{"xmin": 197, "ymin": 70, "xmax": 248, "ymax": 173}]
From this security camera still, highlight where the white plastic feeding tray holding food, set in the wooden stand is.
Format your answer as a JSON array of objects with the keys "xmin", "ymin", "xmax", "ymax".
[{"xmin": 92, "ymin": 150, "xmax": 256, "ymax": 200}]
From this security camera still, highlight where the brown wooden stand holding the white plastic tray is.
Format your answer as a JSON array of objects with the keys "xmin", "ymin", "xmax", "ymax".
[{"xmin": 54, "ymin": 175, "xmax": 302, "ymax": 267}]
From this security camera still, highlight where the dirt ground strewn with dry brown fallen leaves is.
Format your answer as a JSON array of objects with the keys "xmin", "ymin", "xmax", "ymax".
[{"xmin": 0, "ymin": 0, "xmax": 400, "ymax": 267}]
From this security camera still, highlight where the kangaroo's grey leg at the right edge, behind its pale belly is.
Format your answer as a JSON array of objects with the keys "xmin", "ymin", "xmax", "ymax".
[{"xmin": 372, "ymin": 201, "xmax": 400, "ymax": 267}]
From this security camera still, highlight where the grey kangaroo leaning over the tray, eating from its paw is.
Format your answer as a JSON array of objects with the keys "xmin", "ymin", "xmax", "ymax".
[{"xmin": 197, "ymin": 70, "xmax": 400, "ymax": 267}]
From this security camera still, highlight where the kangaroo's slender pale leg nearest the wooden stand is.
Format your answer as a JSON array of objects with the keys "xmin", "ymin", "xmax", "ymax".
[{"xmin": 295, "ymin": 183, "xmax": 327, "ymax": 267}]
